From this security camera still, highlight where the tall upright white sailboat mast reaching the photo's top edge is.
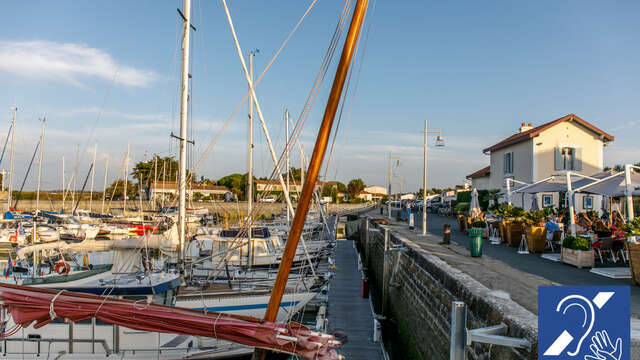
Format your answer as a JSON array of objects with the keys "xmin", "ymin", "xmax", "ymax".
[{"xmin": 178, "ymin": 0, "xmax": 191, "ymax": 262}]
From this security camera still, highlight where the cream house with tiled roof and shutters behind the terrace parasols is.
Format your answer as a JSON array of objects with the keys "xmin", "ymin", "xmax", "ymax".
[{"xmin": 467, "ymin": 114, "xmax": 614, "ymax": 211}]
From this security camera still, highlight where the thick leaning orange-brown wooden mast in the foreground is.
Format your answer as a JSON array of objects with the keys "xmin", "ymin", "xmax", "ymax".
[{"xmin": 264, "ymin": 0, "xmax": 369, "ymax": 321}]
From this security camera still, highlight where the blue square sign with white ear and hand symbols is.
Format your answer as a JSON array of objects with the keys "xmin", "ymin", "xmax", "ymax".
[{"xmin": 538, "ymin": 286, "xmax": 631, "ymax": 360}]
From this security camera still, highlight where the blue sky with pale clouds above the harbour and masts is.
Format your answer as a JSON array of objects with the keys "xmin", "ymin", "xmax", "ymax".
[{"xmin": 0, "ymin": 0, "xmax": 640, "ymax": 191}]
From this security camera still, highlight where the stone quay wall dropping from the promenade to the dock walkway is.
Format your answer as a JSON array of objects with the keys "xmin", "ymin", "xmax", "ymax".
[{"xmin": 357, "ymin": 216, "xmax": 538, "ymax": 360}]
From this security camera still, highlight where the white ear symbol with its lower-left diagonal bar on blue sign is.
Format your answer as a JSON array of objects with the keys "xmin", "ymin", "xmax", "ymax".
[{"xmin": 544, "ymin": 295, "xmax": 595, "ymax": 356}]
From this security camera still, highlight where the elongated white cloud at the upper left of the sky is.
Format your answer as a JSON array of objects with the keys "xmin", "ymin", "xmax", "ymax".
[{"xmin": 0, "ymin": 41, "xmax": 158, "ymax": 87}]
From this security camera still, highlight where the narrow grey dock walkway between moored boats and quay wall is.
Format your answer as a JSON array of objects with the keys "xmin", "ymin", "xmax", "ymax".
[{"xmin": 328, "ymin": 240, "xmax": 384, "ymax": 360}]
